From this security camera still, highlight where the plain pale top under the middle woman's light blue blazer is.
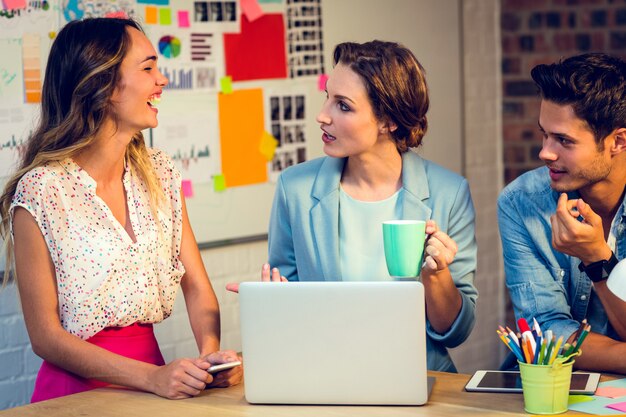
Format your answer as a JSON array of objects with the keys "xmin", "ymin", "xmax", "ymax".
[{"xmin": 339, "ymin": 186, "xmax": 402, "ymax": 281}]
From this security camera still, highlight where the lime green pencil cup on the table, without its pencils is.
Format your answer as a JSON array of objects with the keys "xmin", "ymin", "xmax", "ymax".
[{"xmin": 518, "ymin": 358, "xmax": 574, "ymax": 414}]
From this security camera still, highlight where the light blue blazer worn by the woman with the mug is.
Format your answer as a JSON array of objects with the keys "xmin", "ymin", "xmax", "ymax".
[{"xmin": 268, "ymin": 151, "xmax": 478, "ymax": 371}]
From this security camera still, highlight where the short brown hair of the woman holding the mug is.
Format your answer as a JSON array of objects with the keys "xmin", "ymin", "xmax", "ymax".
[{"xmin": 333, "ymin": 40, "xmax": 429, "ymax": 152}]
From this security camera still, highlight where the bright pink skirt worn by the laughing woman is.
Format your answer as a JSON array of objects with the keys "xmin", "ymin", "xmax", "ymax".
[{"xmin": 30, "ymin": 323, "xmax": 165, "ymax": 403}]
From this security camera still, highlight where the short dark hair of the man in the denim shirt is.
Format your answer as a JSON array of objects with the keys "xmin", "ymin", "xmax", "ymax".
[{"xmin": 530, "ymin": 53, "xmax": 626, "ymax": 149}]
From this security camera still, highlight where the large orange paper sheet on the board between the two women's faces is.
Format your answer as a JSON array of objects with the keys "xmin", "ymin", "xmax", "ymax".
[{"xmin": 217, "ymin": 88, "xmax": 267, "ymax": 188}]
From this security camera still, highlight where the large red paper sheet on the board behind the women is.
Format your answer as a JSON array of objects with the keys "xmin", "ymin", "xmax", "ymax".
[{"xmin": 224, "ymin": 13, "xmax": 287, "ymax": 81}]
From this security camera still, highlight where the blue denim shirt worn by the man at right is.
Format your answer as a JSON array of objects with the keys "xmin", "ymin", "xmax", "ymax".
[{"xmin": 498, "ymin": 167, "xmax": 626, "ymax": 340}]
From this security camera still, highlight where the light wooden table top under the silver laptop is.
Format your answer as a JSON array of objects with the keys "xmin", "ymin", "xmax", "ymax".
[{"xmin": 0, "ymin": 371, "xmax": 584, "ymax": 417}]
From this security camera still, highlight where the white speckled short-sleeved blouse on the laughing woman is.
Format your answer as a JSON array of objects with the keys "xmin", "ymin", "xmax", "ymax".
[{"xmin": 10, "ymin": 149, "xmax": 185, "ymax": 339}]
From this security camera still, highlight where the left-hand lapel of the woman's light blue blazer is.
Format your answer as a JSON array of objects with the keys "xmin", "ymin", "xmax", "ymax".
[{"xmin": 311, "ymin": 158, "xmax": 345, "ymax": 281}]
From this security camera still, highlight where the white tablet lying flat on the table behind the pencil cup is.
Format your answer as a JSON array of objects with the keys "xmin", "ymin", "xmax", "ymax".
[{"xmin": 465, "ymin": 371, "xmax": 600, "ymax": 394}]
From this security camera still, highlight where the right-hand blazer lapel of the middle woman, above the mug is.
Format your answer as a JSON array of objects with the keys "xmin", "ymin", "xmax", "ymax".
[{"xmin": 402, "ymin": 151, "xmax": 432, "ymax": 220}]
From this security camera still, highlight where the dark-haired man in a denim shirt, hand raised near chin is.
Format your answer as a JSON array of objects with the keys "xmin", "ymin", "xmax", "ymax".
[{"xmin": 498, "ymin": 54, "xmax": 626, "ymax": 373}]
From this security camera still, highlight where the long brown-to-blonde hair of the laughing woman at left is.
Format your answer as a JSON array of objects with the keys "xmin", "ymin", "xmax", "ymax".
[{"xmin": 0, "ymin": 18, "xmax": 164, "ymax": 284}]
